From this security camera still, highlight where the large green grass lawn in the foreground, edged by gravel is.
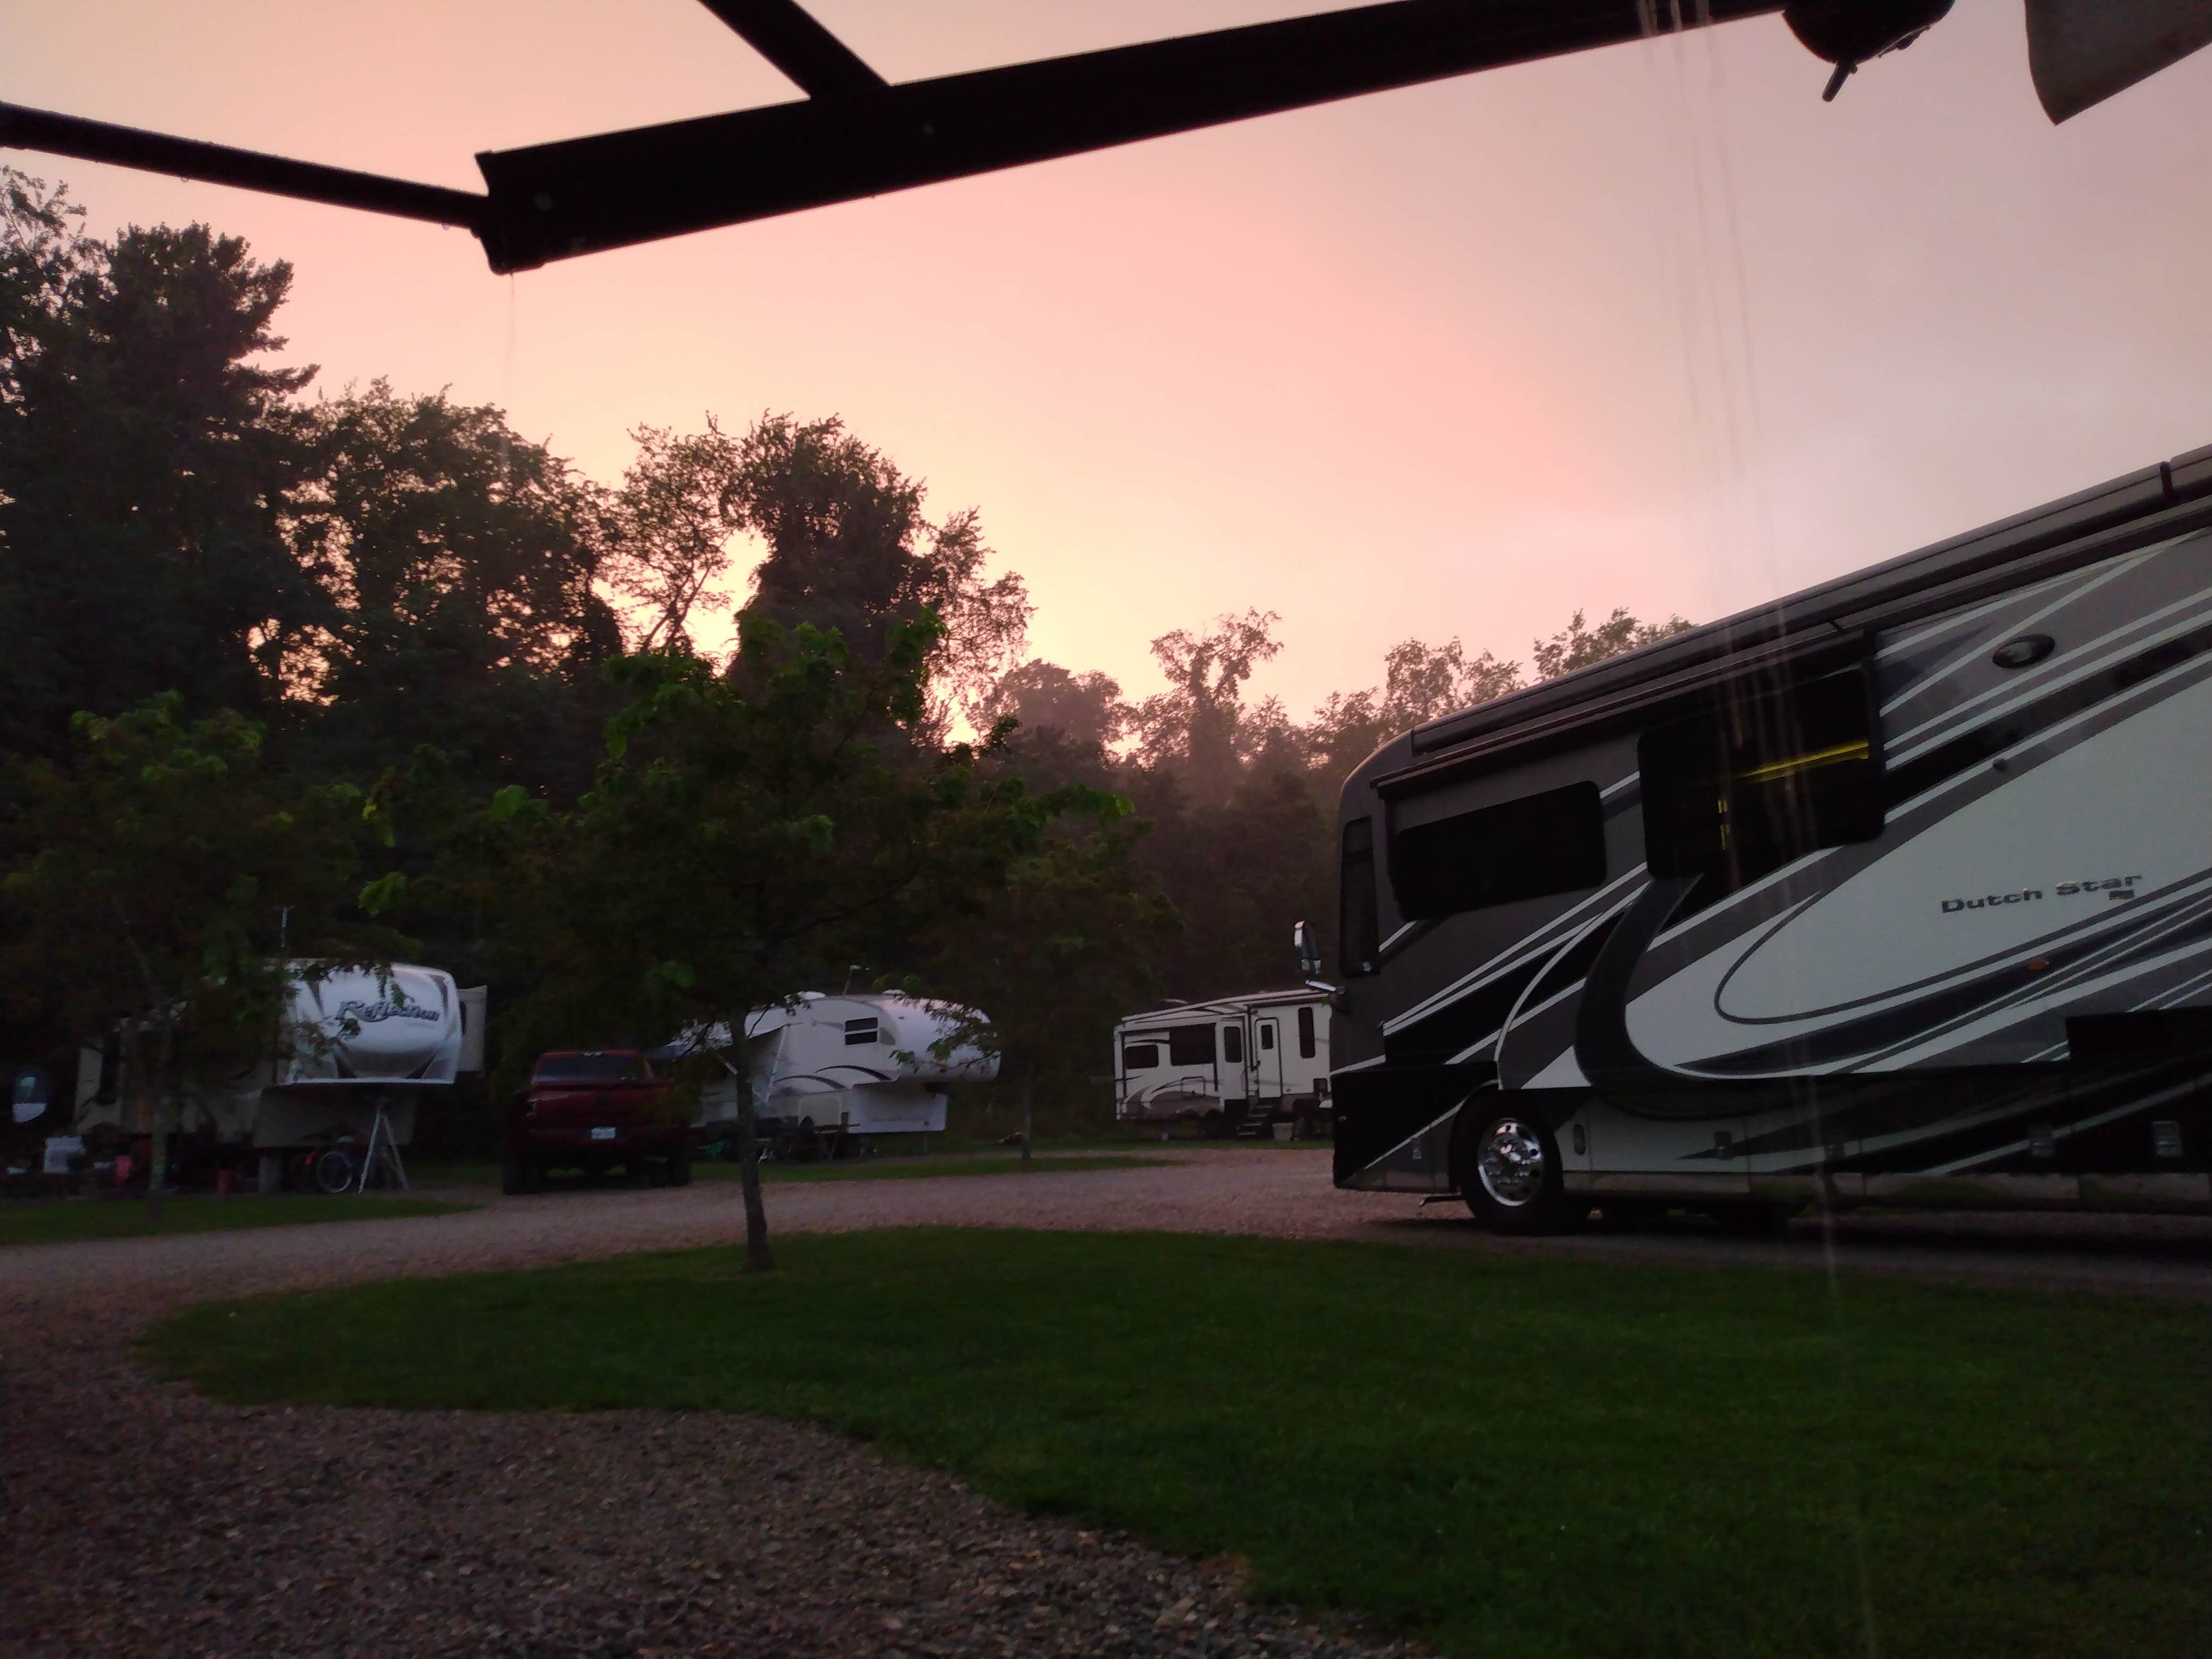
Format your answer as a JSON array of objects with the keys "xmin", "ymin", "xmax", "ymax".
[{"xmin": 146, "ymin": 1230, "xmax": 2212, "ymax": 1659}]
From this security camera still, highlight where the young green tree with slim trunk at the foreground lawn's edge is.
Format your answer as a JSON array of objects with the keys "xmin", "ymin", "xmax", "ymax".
[{"xmin": 458, "ymin": 613, "xmax": 1102, "ymax": 1270}]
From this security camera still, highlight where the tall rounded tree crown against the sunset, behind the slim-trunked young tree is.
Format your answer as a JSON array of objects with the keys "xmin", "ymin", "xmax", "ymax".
[{"xmin": 730, "ymin": 416, "xmax": 1031, "ymax": 734}]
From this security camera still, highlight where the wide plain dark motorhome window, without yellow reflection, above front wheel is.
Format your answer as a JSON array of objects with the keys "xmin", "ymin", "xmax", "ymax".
[{"xmin": 1389, "ymin": 783, "xmax": 1606, "ymax": 920}]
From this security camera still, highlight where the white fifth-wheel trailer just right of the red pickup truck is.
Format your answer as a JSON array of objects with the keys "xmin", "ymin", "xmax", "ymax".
[{"xmin": 652, "ymin": 991, "xmax": 998, "ymax": 1159}]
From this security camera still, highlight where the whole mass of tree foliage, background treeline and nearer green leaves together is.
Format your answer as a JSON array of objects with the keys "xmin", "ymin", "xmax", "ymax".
[{"xmin": 0, "ymin": 168, "xmax": 1688, "ymax": 1141}]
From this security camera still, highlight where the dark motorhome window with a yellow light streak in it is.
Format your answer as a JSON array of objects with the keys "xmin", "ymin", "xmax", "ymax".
[{"xmin": 1637, "ymin": 668, "xmax": 1882, "ymax": 889}]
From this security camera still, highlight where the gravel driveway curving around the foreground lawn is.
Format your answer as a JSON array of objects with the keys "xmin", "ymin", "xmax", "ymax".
[{"xmin": 0, "ymin": 1148, "xmax": 2212, "ymax": 1659}]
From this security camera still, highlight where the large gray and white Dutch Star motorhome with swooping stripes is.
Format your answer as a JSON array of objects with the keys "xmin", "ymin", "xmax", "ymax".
[{"xmin": 1331, "ymin": 449, "xmax": 2212, "ymax": 1230}]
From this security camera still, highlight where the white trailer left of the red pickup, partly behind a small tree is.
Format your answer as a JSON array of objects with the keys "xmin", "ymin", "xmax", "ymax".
[{"xmin": 75, "ymin": 962, "xmax": 484, "ymax": 1186}]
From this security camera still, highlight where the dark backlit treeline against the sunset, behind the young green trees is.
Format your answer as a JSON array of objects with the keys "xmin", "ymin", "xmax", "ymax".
[{"xmin": 0, "ymin": 170, "xmax": 1688, "ymax": 1132}]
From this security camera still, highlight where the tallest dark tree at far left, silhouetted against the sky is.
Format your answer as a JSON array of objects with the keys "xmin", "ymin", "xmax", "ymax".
[{"xmin": 0, "ymin": 172, "xmax": 325, "ymax": 759}]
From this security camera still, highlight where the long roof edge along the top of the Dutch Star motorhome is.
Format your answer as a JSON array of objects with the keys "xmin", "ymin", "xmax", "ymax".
[{"xmin": 1411, "ymin": 447, "xmax": 2212, "ymax": 757}]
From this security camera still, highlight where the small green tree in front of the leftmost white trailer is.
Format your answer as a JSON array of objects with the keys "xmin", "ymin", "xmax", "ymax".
[{"xmin": 0, "ymin": 692, "xmax": 398, "ymax": 1203}]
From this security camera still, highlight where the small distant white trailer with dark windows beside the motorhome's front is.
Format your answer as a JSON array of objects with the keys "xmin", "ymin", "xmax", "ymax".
[{"xmin": 1112, "ymin": 991, "xmax": 1329, "ymax": 1135}]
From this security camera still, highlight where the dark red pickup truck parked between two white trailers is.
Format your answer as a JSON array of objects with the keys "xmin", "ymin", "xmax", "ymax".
[{"xmin": 500, "ymin": 1049, "xmax": 692, "ymax": 1192}]
